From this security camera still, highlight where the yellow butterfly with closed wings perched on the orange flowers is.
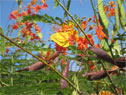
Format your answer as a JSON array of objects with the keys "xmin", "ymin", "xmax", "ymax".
[{"xmin": 50, "ymin": 32, "xmax": 69, "ymax": 47}]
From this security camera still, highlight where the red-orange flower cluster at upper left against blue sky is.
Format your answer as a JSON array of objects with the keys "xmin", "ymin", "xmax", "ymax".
[{"xmin": 9, "ymin": 0, "xmax": 48, "ymax": 41}]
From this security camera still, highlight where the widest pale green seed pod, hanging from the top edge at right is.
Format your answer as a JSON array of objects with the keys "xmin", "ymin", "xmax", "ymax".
[{"xmin": 97, "ymin": 0, "xmax": 109, "ymax": 34}]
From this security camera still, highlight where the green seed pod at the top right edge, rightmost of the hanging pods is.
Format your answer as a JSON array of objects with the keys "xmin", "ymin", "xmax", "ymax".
[{"xmin": 117, "ymin": 0, "xmax": 126, "ymax": 32}]
